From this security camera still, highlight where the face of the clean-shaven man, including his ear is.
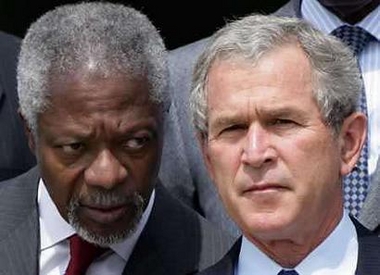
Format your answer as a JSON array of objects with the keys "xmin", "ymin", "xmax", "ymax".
[{"xmin": 203, "ymin": 45, "xmax": 365, "ymax": 248}]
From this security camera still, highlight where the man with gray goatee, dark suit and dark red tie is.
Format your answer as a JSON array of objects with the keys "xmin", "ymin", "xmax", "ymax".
[{"xmin": 0, "ymin": 2, "xmax": 229, "ymax": 275}]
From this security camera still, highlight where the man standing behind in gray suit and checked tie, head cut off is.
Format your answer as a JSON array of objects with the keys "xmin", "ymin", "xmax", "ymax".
[{"xmin": 163, "ymin": 0, "xmax": 380, "ymax": 239}]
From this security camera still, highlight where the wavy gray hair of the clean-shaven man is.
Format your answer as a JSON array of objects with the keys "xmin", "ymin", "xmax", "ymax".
[{"xmin": 190, "ymin": 15, "xmax": 362, "ymax": 136}]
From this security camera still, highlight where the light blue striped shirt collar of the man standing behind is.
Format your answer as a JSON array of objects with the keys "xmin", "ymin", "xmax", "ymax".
[{"xmin": 301, "ymin": 0, "xmax": 380, "ymax": 41}]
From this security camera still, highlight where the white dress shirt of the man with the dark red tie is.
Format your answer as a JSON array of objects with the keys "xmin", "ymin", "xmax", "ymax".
[{"xmin": 38, "ymin": 179, "xmax": 155, "ymax": 275}]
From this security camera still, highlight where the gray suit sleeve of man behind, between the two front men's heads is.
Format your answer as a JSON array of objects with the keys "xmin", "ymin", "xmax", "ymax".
[{"xmin": 160, "ymin": 39, "xmax": 240, "ymax": 237}]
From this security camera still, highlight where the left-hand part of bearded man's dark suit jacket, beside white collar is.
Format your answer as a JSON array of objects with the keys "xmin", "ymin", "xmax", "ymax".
[{"xmin": 0, "ymin": 169, "xmax": 40, "ymax": 275}]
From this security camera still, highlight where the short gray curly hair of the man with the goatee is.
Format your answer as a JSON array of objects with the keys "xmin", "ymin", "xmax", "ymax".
[{"xmin": 17, "ymin": 2, "xmax": 168, "ymax": 132}]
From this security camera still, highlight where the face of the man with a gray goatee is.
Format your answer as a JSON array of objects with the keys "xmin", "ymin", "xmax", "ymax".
[{"xmin": 28, "ymin": 71, "xmax": 162, "ymax": 245}]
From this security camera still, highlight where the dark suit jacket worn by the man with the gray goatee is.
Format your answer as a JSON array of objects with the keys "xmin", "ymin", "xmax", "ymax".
[{"xmin": 0, "ymin": 168, "xmax": 233, "ymax": 275}]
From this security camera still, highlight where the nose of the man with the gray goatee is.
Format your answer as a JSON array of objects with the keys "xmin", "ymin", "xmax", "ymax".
[{"xmin": 84, "ymin": 149, "xmax": 128, "ymax": 189}]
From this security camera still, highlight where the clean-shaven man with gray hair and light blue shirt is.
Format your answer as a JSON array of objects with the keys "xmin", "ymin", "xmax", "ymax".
[{"xmin": 190, "ymin": 15, "xmax": 380, "ymax": 275}]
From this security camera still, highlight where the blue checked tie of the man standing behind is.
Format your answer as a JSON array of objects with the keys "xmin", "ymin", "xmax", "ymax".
[{"xmin": 331, "ymin": 26, "xmax": 374, "ymax": 217}]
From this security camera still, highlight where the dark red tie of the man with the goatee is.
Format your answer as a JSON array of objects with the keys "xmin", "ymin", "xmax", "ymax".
[{"xmin": 65, "ymin": 235, "xmax": 106, "ymax": 275}]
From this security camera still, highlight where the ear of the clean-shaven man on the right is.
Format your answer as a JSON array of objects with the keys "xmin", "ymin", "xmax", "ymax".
[{"xmin": 339, "ymin": 112, "xmax": 367, "ymax": 176}]
